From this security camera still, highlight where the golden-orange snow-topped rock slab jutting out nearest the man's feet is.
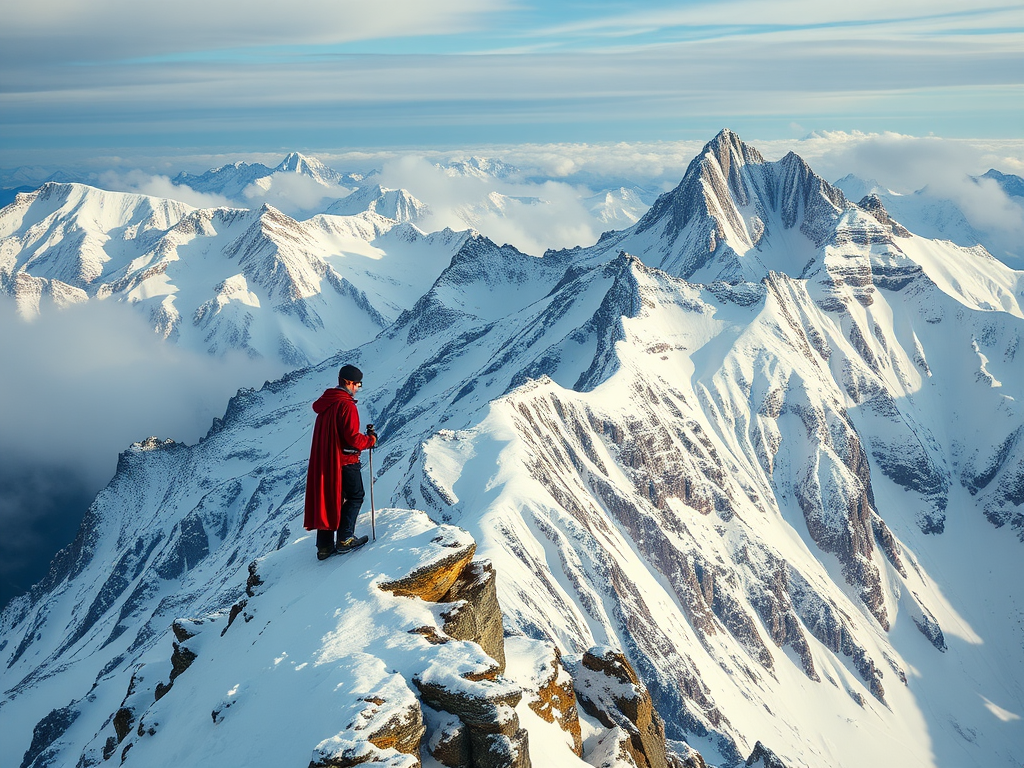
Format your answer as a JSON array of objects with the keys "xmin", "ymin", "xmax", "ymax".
[{"xmin": 378, "ymin": 525, "xmax": 476, "ymax": 602}]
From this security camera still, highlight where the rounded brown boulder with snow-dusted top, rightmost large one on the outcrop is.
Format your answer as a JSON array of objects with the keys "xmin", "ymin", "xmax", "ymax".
[{"xmin": 572, "ymin": 646, "xmax": 669, "ymax": 768}]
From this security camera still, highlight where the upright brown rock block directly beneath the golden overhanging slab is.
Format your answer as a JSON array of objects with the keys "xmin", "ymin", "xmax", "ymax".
[{"xmin": 441, "ymin": 560, "xmax": 505, "ymax": 672}]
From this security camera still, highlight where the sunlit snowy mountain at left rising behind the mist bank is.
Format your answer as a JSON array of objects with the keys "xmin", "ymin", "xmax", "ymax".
[{"xmin": 0, "ymin": 184, "xmax": 466, "ymax": 367}]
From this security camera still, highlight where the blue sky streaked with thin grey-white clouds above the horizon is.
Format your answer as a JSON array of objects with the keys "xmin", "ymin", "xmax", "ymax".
[{"xmin": 0, "ymin": 0, "xmax": 1024, "ymax": 162}]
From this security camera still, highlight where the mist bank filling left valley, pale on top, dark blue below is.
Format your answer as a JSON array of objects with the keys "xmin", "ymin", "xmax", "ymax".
[{"xmin": 0, "ymin": 297, "xmax": 282, "ymax": 604}]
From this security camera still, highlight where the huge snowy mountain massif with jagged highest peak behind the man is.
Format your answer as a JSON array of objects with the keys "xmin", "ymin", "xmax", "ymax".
[{"xmin": 0, "ymin": 131, "xmax": 1024, "ymax": 768}]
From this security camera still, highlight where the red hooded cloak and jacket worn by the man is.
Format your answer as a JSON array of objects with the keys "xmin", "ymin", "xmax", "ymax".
[{"xmin": 303, "ymin": 388, "xmax": 374, "ymax": 530}]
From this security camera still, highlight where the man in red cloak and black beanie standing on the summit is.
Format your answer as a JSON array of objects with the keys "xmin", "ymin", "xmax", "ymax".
[{"xmin": 304, "ymin": 366, "xmax": 377, "ymax": 560}]
